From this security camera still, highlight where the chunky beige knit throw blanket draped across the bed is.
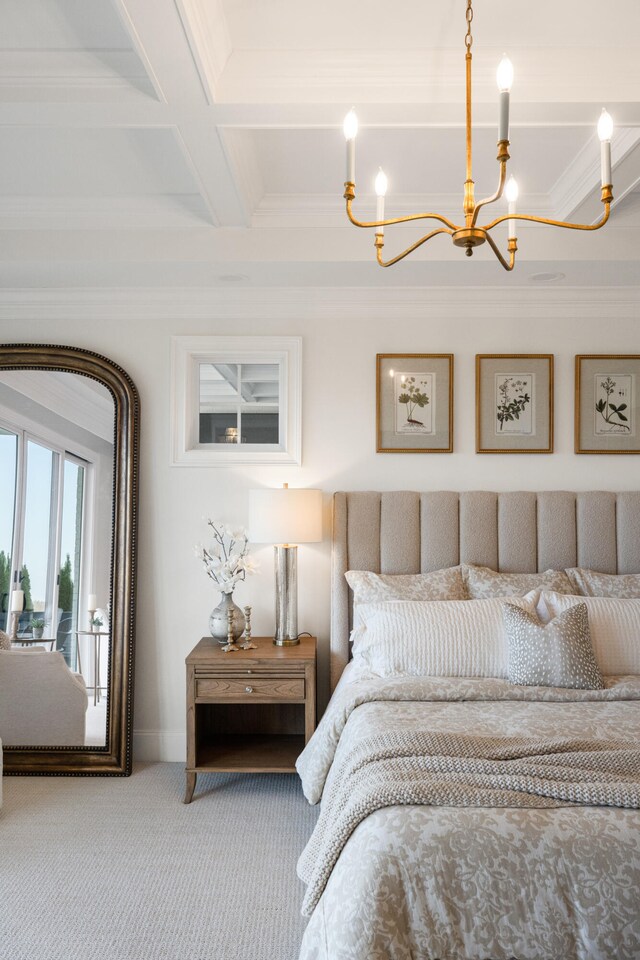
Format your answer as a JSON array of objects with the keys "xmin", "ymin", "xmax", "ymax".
[{"xmin": 298, "ymin": 731, "xmax": 640, "ymax": 916}]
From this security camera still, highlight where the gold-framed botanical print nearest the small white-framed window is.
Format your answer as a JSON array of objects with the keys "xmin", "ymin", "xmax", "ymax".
[{"xmin": 376, "ymin": 353, "xmax": 453, "ymax": 453}]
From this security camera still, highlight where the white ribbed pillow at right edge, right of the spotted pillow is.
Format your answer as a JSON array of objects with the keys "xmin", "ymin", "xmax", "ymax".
[{"xmin": 538, "ymin": 590, "xmax": 640, "ymax": 676}]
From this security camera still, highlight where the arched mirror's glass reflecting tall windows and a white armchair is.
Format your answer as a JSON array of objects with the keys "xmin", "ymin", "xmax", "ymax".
[{"xmin": 0, "ymin": 370, "xmax": 115, "ymax": 747}]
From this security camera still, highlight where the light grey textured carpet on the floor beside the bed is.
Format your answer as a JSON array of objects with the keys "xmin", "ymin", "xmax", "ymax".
[{"xmin": 0, "ymin": 763, "xmax": 318, "ymax": 960}]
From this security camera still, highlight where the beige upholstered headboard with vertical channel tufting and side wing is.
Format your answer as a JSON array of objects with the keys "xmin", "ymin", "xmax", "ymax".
[{"xmin": 331, "ymin": 490, "xmax": 640, "ymax": 689}]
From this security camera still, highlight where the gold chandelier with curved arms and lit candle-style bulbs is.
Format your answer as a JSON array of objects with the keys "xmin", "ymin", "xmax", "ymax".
[{"xmin": 344, "ymin": 0, "xmax": 613, "ymax": 270}]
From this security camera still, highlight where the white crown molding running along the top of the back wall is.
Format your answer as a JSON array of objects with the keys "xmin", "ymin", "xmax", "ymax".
[{"xmin": 0, "ymin": 285, "xmax": 640, "ymax": 326}]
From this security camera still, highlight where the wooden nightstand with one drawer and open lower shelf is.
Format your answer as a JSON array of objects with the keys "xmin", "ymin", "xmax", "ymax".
[{"xmin": 184, "ymin": 637, "xmax": 316, "ymax": 803}]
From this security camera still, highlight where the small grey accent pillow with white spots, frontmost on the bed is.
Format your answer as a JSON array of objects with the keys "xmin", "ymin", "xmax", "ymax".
[{"xmin": 503, "ymin": 603, "xmax": 604, "ymax": 690}]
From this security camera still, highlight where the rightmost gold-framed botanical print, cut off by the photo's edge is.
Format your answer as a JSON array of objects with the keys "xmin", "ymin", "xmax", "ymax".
[{"xmin": 575, "ymin": 354, "xmax": 640, "ymax": 453}]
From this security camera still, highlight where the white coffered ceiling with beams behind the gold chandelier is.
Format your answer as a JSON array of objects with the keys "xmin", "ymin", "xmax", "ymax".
[{"xmin": 0, "ymin": 0, "xmax": 640, "ymax": 288}]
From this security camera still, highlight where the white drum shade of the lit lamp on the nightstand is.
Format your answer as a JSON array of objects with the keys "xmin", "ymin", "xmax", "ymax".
[{"xmin": 249, "ymin": 487, "xmax": 322, "ymax": 543}]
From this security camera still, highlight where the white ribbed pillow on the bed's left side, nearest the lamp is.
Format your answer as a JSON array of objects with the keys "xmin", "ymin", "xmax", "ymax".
[{"xmin": 353, "ymin": 597, "xmax": 535, "ymax": 677}]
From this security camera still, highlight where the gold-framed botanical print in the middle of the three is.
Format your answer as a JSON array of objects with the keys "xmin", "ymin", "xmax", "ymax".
[{"xmin": 476, "ymin": 353, "xmax": 553, "ymax": 453}]
